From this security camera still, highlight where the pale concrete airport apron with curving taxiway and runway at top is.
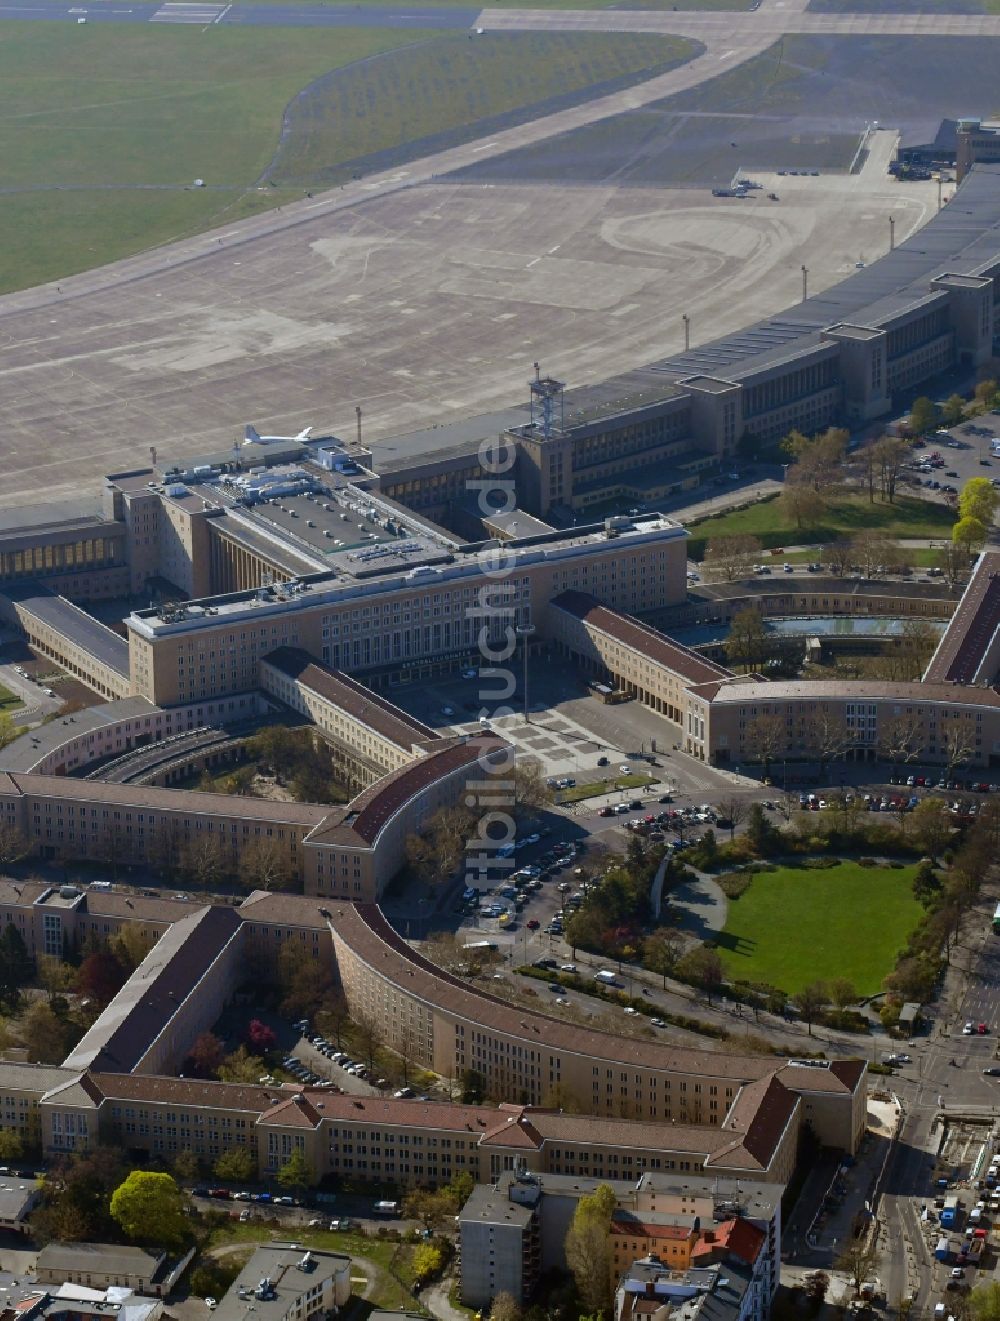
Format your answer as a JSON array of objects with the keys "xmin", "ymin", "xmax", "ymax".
[{"xmin": 0, "ymin": 0, "xmax": 1000, "ymax": 505}]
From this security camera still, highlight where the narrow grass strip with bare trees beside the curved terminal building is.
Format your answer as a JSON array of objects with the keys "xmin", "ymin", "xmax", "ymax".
[{"xmin": 687, "ymin": 494, "xmax": 955, "ymax": 560}]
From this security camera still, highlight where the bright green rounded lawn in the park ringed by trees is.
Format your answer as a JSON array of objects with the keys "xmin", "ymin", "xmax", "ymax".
[{"xmin": 717, "ymin": 863, "xmax": 923, "ymax": 996}]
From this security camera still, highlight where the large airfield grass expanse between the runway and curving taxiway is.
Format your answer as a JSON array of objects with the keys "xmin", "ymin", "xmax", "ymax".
[{"xmin": 0, "ymin": 22, "xmax": 696, "ymax": 292}]
